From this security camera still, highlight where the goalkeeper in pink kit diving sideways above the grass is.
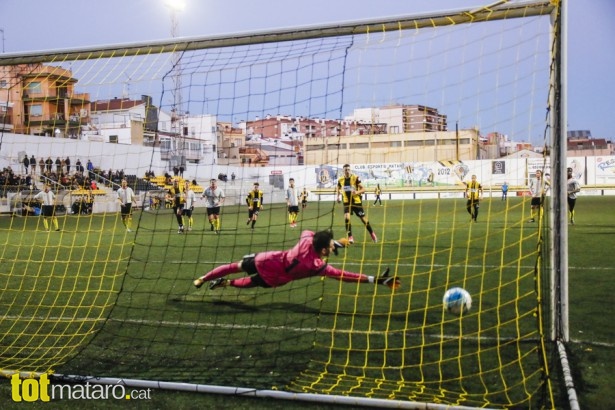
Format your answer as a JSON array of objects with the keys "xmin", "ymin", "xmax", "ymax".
[{"xmin": 193, "ymin": 230, "xmax": 401, "ymax": 289}]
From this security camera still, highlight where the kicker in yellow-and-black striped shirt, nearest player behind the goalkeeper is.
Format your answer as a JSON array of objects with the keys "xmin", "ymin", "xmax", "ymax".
[{"xmin": 336, "ymin": 164, "xmax": 378, "ymax": 243}]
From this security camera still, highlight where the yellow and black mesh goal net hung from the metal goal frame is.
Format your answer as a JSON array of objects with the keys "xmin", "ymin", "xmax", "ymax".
[{"xmin": 0, "ymin": 1, "xmax": 561, "ymax": 408}]
